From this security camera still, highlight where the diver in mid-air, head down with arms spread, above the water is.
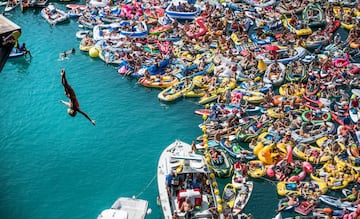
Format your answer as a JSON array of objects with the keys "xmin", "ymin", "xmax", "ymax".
[{"xmin": 60, "ymin": 69, "xmax": 96, "ymax": 125}]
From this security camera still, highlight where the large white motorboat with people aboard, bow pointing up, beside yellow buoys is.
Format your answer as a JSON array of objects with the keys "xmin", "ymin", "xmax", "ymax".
[{"xmin": 157, "ymin": 140, "xmax": 222, "ymax": 219}]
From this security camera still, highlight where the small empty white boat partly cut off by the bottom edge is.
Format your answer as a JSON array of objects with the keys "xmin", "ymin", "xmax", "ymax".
[{"xmin": 97, "ymin": 197, "xmax": 151, "ymax": 219}]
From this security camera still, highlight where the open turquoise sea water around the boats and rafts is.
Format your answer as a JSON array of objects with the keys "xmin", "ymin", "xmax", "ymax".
[{"xmin": 0, "ymin": 4, "xmax": 352, "ymax": 219}]
